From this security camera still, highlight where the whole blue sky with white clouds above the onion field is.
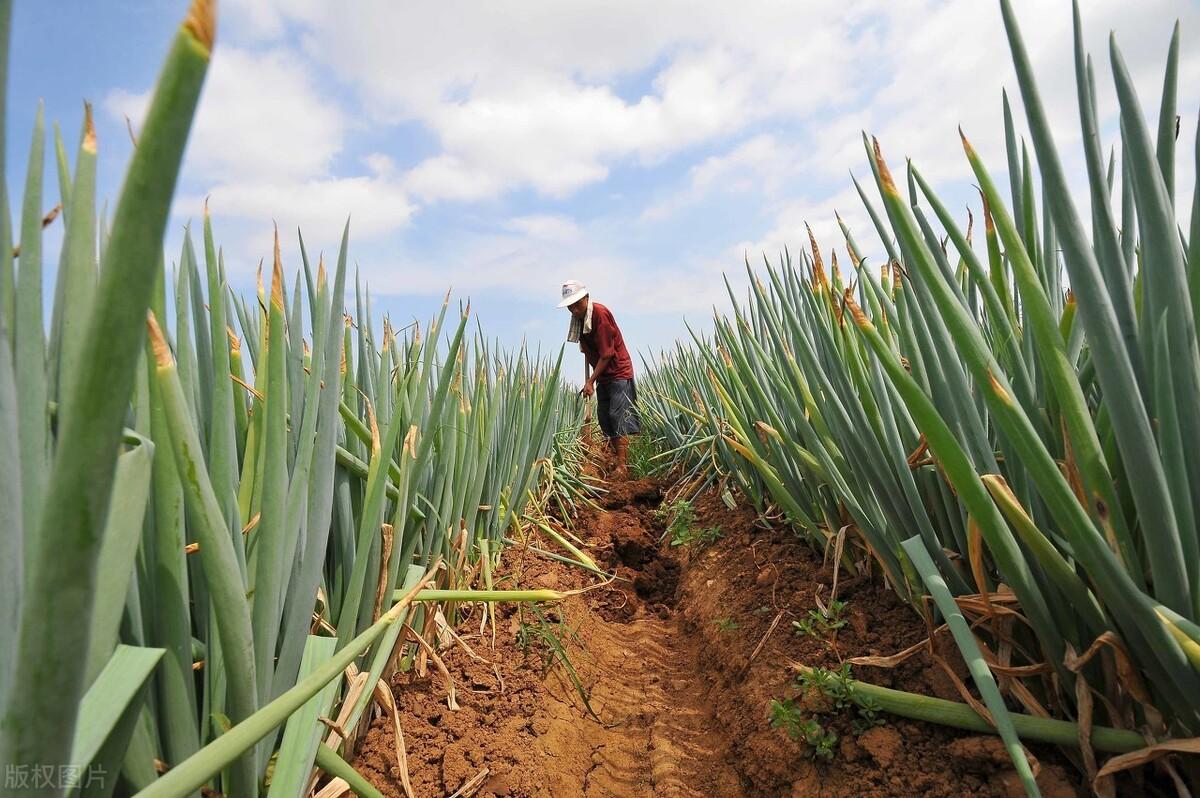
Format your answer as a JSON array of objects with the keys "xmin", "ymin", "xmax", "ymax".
[{"xmin": 7, "ymin": 0, "xmax": 1200, "ymax": 364}]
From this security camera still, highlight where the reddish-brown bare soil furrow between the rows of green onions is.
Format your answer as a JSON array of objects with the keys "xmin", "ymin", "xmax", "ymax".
[{"xmin": 354, "ymin": 470, "xmax": 1084, "ymax": 798}]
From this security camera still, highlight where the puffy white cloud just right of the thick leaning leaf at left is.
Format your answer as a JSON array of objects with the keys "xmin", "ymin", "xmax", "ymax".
[{"xmin": 106, "ymin": 42, "xmax": 416, "ymax": 256}]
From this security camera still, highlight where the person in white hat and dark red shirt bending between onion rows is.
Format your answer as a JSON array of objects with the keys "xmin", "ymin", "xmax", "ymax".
[{"xmin": 558, "ymin": 280, "xmax": 642, "ymax": 478}]
